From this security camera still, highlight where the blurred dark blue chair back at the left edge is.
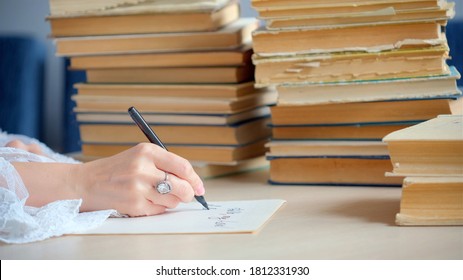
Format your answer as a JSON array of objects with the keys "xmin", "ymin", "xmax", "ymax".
[{"xmin": 0, "ymin": 35, "xmax": 46, "ymax": 139}]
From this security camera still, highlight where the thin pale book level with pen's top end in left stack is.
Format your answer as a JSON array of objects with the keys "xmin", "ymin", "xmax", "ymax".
[{"xmin": 75, "ymin": 106, "xmax": 270, "ymax": 125}]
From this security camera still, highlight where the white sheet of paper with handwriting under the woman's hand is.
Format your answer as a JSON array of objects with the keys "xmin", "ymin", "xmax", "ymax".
[{"xmin": 80, "ymin": 199, "xmax": 286, "ymax": 234}]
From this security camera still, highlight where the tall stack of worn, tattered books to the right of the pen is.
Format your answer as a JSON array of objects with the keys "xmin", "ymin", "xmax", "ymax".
[{"xmin": 252, "ymin": 0, "xmax": 463, "ymax": 186}]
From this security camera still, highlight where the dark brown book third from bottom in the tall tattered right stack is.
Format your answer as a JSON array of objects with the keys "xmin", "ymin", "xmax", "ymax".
[{"xmin": 272, "ymin": 122, "xmax": 417, "ymax": 140}]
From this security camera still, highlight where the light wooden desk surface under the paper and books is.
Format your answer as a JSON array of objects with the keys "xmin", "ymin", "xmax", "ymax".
[{"xmin": 0, "ymin": 170, "xmax": 463, "ymax": 260}]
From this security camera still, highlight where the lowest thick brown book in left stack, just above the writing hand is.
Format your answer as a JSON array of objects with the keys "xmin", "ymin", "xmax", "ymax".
[{"xmin": 82, "ymin": 139, "xmax": 267, "ymax": 164}]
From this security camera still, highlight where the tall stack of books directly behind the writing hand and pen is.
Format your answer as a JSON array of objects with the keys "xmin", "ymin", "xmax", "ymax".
[{"xmin": 48, "ymin": 0, "xmax": 276, "ymax": 176}]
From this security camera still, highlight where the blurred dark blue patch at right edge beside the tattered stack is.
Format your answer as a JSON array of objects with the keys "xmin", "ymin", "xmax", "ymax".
[{"xmin": 445, "ymin": 20, "xmax": 463, "ymax": 87}]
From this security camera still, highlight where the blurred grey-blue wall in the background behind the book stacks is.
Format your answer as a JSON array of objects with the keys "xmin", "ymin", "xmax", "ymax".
[{"xmin": 0, "ymin": 0, "xmax": 463, "ymax": 151}]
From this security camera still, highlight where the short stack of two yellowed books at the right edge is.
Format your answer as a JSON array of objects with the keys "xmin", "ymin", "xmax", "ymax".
[{"xmin": 383, "ymin": 115, "xmax": 463, "ymax": 225}]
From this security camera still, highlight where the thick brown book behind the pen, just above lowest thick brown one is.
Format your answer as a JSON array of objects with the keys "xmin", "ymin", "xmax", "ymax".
[{"xmin": 79, "ymin": 118, "xmax": 271, "ymax": 145}]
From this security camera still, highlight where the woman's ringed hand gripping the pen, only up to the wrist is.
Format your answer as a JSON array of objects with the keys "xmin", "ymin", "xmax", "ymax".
[{"xmin": 74, "ymin": 143, "xmax": 204, "ymax": 216}]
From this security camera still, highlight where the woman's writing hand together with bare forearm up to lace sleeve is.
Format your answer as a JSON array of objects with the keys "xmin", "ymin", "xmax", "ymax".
[{"xmin": 13, "ymin": 143, "xmax": 204, "ymax": 216}]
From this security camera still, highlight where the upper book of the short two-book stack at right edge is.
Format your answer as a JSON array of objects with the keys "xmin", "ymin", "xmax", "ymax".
[{"xmin": 383, "ymin": 115, "xmax": 463, "ymax": 176}]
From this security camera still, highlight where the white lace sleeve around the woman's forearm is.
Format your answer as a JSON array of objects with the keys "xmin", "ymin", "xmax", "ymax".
[{"xmin": 0, "ymin": 131, "xmax": 115, "ymax": 243}]
